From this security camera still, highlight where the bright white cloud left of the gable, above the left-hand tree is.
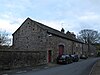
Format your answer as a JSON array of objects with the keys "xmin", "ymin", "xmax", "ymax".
[{"xmin": 0, "ymin": 12, "xmax": 24, "ymax": 34}]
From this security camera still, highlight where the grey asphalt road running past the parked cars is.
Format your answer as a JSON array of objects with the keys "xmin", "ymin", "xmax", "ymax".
[{"xmin": 12, "ymin": 58, "xmax": 98, "ymax": 75}]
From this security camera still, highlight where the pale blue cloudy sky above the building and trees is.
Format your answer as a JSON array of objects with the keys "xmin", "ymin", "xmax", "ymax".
[{"xmin": 0, "ymin": 0, "xmax": 100, "ymax": 34}]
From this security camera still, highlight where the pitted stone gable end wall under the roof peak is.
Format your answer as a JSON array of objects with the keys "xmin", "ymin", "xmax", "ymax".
[{"xmin": 13, "ymin": 20, "xmax": 46, "ymax": 51}]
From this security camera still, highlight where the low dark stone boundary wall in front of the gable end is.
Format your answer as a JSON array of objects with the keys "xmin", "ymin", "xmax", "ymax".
[{"xmin": 0, "ymin": 51, "xmax": 46, "ymax": 71}]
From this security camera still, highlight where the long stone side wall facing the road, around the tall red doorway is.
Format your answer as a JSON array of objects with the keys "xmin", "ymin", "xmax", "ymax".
[{"xmin": 46, "ymin": 34, "xmax": 82, "ymax": 62}]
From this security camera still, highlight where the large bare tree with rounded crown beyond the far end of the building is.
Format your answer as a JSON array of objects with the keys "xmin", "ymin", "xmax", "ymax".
[{"xmin": 77, "ymin": 29, "xmax": 100, "ymax": 44}]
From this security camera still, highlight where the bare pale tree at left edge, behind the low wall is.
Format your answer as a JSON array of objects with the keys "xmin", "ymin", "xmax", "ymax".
[{"xmin": 0, "ymin": 31, "xmax": 11, "ymax": 46}]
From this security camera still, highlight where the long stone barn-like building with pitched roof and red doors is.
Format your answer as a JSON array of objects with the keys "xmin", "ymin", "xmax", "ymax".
[{"xmin": 13, "ymin": 18, "xmax": 96, "ymax": 63}]
